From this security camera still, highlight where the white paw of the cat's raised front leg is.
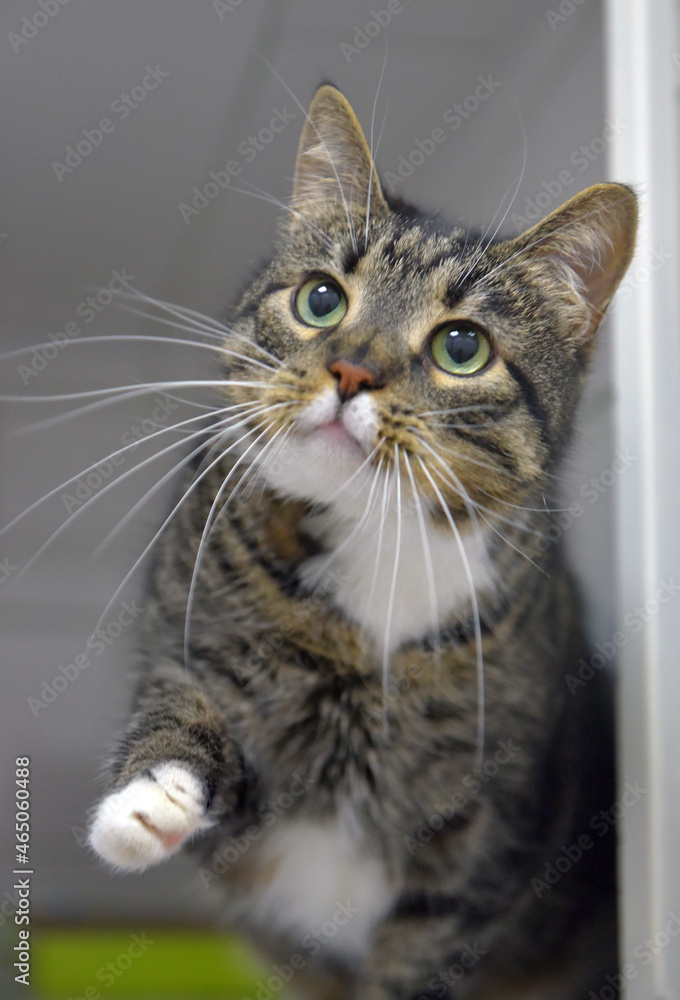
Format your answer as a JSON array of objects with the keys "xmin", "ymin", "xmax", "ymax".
[{"xmin": 88, "ymin": 762, "xmax": 213, "ymax": 871}]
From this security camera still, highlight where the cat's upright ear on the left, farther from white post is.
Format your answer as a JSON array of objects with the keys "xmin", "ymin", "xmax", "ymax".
[{"xmin": 291, "ymin": 85, "xmax": 389, "ymax": 228}]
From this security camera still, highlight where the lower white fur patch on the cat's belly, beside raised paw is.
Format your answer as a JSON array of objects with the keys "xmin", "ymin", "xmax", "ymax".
[{"xmin": 249, "ymin": 815, "xmax": 394, "ymax": 961}]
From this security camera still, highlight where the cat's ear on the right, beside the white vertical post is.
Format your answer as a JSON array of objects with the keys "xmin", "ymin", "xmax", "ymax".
[{"xmin": 515, "ymin": 184, "xmax": 637, "ymax": 342}]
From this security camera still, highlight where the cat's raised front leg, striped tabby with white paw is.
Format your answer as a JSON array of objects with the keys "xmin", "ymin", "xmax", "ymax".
[{"xmin": 88, "ymin": 668, "xmax": 243, "ymax": 871}]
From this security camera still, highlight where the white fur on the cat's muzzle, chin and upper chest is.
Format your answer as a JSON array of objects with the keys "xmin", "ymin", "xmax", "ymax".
[{"xmin": 255, "ymin": 389, "xmax": 497, "ymax": 657}]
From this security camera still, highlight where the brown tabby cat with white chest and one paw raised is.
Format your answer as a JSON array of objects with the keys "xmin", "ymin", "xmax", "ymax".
[{"xmin": 89, "ymin": 85, "xmax": 637, "ymax": 1000}]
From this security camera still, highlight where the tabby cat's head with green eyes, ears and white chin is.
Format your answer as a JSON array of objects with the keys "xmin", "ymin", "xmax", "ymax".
[{"xmin": 227, "ymin": 86, "xmax": 637, "ymax": 519}]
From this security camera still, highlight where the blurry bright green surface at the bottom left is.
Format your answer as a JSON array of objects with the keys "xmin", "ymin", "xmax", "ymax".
[{"xmin": 31, "ymin": 928, "xmax": 271, "ymax": 1000}]
